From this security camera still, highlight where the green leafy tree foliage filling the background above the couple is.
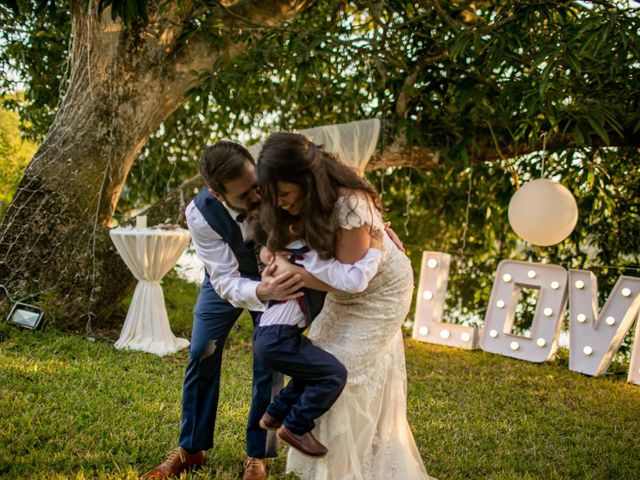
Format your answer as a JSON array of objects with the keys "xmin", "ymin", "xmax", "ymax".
[{"xmin": 0, "ymin": 0, "xmax": 640, "ymax": 338}]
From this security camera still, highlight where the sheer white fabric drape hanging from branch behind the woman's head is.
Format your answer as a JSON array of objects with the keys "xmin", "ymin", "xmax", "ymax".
[{"xmin": 249, "ymin": 118, "xmax": 380, "ymax": 174}]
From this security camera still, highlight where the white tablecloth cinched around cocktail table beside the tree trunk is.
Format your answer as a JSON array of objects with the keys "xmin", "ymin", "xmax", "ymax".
[{"xmin": 109, "ymin": 227, "xmax": 190, "ymax": 356}]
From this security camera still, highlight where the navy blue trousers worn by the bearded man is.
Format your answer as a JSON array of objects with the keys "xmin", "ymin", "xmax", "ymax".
[{"xmin": 179, "ymin": 274, "xmax": 282, "ymax": 458}]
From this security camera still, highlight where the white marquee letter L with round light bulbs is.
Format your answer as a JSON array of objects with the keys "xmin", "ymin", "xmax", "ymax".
[{"xmin": 413, "ymin": 252, "xmax": 478, "ymax": 350}]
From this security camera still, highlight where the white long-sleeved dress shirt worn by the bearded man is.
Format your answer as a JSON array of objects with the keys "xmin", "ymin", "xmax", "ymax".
[{"xmin": 185, "ymin": 201, "xmax": 267, "ymax": 312}]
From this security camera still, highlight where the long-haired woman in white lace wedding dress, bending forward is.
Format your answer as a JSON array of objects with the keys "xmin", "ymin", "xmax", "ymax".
[{"xmin": 258, "ymin": 133, "xmax": 429, "ymax": 480}]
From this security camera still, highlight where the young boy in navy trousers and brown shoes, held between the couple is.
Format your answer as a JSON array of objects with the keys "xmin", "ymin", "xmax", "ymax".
[{"xmin": 253, "ymin": 222, "xmax": 382, "ymax": 457}]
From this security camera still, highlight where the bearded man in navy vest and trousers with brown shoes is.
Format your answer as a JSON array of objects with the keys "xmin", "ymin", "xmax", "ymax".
[{"xmin": 143, "ymin": 141, "xmax": 304, "ymax": 480}]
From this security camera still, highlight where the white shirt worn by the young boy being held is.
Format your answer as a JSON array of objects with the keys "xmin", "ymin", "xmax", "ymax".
[{"xmin": 259, "ymin": 240, "xmax": 381, "ymax": 328}]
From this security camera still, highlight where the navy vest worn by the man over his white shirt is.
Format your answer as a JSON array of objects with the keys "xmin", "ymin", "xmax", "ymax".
[{"xmin": 193, "ymin": 188, "xmax": 260, "ymax": 279}]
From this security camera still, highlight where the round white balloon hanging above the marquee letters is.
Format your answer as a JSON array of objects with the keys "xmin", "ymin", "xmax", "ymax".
[{"xmin": 509, "ymin": 178, "xmax": 578, "ymax": 247}]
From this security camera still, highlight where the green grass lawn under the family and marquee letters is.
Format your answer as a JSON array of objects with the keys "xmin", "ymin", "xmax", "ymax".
[{"xmin": 0, "ymin": 276, "xmax": 640, "ymax": 480}]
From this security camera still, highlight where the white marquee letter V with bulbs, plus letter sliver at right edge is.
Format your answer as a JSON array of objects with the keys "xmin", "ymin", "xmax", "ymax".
[{"xmin": 569, "ymin": 270, "xmax": 640, "ymax": 385}]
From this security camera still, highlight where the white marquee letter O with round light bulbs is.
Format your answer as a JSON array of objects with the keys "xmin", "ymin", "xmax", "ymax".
[{"xmin": 480, "ymin": 260, "xmax": 567, "ymax": 362}]
